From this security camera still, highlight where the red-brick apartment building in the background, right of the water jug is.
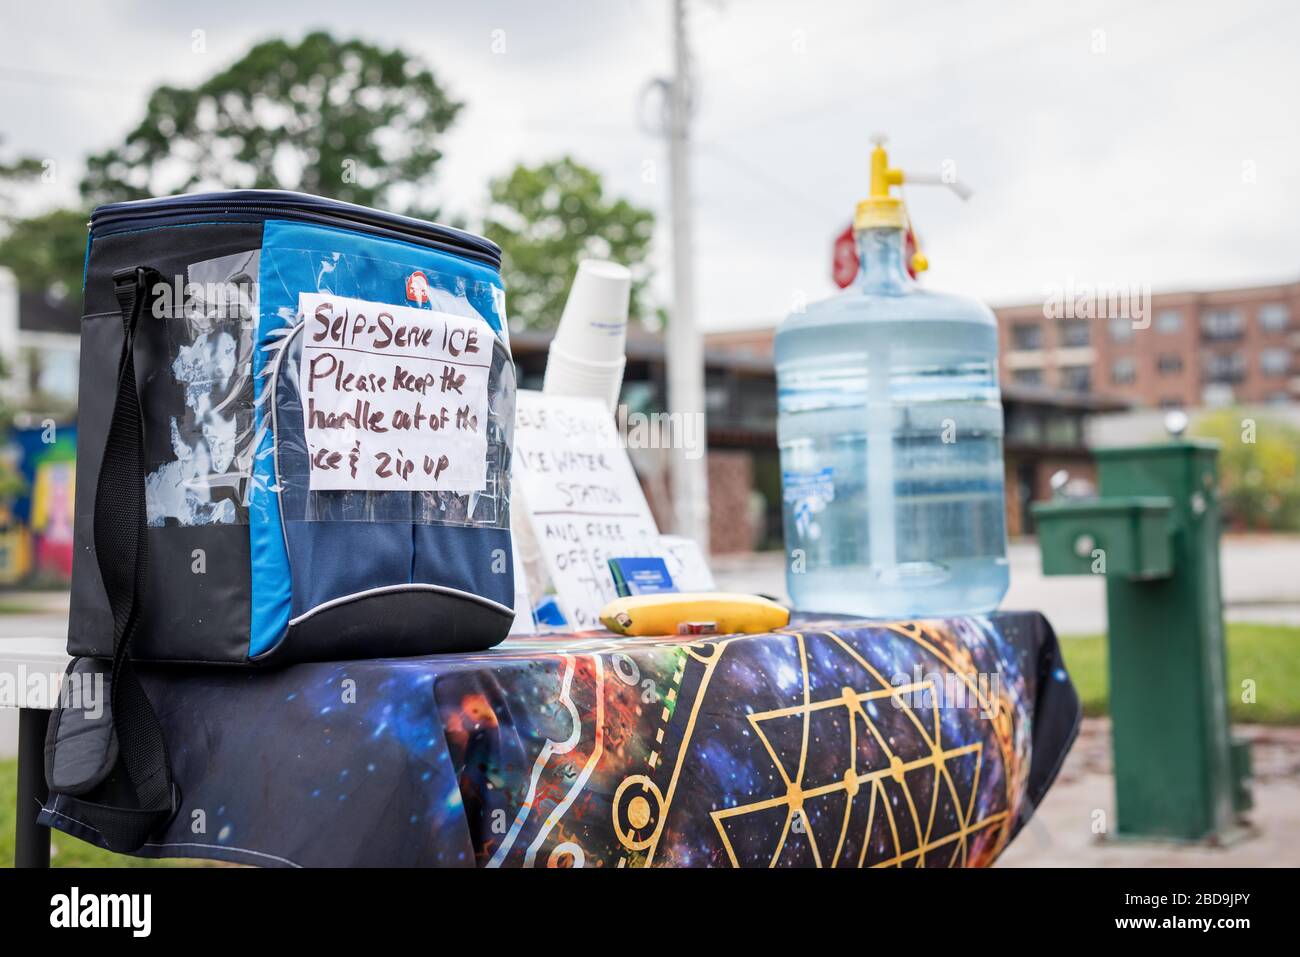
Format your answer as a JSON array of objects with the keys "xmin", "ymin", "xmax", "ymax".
[{"xmin": 995, "ymin": 282, "xmax": 1300, "ymax": 408}]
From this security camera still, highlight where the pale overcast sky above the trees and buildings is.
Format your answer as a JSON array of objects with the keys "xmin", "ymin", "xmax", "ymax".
[{"xmin": 0, "ymin": 0, "xmax": 1300, "ymax": 329}]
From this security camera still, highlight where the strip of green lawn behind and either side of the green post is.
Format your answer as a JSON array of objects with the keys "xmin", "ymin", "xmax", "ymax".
[{"xmin": 1061, "ymin": 623, "xmax": 1300, "ymax": 724}]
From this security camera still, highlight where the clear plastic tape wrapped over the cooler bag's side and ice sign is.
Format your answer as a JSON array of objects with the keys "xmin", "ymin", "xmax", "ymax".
[{"xmin": 146, "ymin": 248, "xmax": 515, "ymax": 529}]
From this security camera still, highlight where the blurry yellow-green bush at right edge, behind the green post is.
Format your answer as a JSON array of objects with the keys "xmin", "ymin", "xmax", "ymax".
[{"xmin": 1192, "ymin": 408, "xmax": 1300, "ymax": 531}]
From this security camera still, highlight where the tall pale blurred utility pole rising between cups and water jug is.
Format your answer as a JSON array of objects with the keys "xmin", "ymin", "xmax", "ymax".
[{"xmin": 667, "ymin": 0, "xmax": 709, "ymax": 555}]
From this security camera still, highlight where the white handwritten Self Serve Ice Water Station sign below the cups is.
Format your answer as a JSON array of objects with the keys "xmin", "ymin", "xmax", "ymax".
[{"xmin": 514, "ymin": 391, "xmax": 659, "ymax": 631}]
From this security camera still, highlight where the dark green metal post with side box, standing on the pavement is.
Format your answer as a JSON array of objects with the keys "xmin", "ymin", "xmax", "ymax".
[{"xmin": 1034, "ymin": 439, "xmax": 1251, "ymax": 841}]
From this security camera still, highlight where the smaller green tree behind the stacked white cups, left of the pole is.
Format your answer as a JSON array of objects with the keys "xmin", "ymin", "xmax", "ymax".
[{"xmin": 484, "ymin": 156, "xmax": 654, "ymax": 329}]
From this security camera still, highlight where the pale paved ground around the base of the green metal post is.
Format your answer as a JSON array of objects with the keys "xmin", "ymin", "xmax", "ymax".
[{"xmin": 998, "ymin": 718, "xmax": 1300, "ymax": 867}]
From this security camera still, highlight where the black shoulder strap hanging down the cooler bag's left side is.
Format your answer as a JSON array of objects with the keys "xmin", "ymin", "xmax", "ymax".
[{"xmin": 67, "ymin": 267, "xmax": 179, "ymax": 852}]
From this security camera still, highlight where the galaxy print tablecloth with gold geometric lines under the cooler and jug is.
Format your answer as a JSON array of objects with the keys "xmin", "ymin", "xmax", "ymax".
[{"xmin": 42, "ymin": 612, "xmax": 1079, "ymax": 867}]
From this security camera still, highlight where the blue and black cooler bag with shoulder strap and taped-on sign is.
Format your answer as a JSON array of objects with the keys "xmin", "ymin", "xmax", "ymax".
[{"xmin": 46, "ymin": 190, "xmax": 515, "ymax": 850}]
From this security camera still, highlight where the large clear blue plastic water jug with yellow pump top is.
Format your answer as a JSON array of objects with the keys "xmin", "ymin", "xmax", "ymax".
[{"xmin": 775, "ymin": 146, "xmax": 1009, "ymax": 618}]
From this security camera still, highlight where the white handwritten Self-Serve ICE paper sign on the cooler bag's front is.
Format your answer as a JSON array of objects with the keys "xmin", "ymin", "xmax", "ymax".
[{"xmin": 298, "ymin": 293, "xmax": 494, "ymax": 492}]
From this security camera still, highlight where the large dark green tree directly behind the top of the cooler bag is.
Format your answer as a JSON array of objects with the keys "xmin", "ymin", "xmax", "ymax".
[{"xmin": 82, "ymin": 33, "xmax": 463, "ymax": 215}]
